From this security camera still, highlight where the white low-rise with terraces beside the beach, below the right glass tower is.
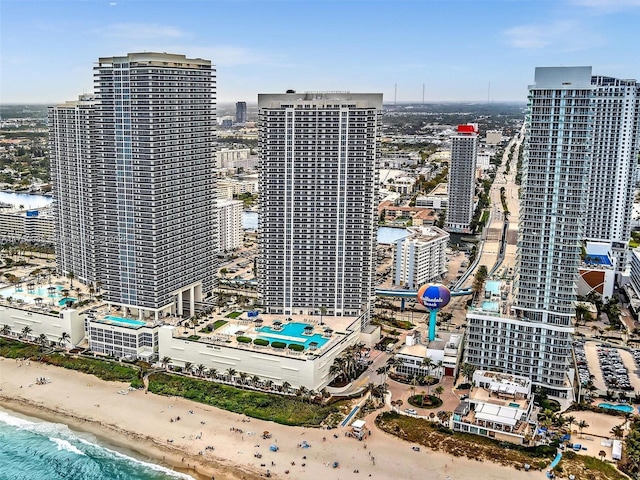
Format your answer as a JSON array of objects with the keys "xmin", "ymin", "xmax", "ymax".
[{"xmin": 451, "ymin": 370, "xmax": 536, "ymax": 444}]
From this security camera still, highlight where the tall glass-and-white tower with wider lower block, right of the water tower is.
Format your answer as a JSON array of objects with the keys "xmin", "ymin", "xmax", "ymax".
[{"xmin": 465, "ymin": 67, "xmax": 594, "ymax": 401}]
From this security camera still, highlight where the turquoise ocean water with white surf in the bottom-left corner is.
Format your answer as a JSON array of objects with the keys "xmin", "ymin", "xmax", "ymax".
[{"xmin": 0, "ymin": 409, "xmax": 193, "ymax": 480}]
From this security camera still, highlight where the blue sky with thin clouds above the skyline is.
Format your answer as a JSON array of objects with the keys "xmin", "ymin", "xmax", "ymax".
[{"xmin": 0, "ymin": 0, "xmax": 640, "ymax": 103}]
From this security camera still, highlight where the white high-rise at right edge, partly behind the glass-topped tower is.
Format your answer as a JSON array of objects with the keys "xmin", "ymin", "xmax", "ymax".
[{"xmin": 585, "ymin": 76, "xmax": 640, "ymax": 272}]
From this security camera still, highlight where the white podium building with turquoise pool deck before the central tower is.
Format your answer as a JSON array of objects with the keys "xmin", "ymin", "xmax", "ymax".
[{"xmin": 158, "ymin": 312, "xmax": 362, "ymax": 391}]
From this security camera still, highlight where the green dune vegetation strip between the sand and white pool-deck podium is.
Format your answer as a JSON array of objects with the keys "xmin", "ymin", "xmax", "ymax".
[{"xmin": 149, "ymin": 373, "xmax": 338, "ymax": 426}]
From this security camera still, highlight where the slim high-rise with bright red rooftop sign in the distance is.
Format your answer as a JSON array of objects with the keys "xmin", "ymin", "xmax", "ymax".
[{"xmin": 445, "ymin": 124, "xmax": 478, "ymax": 233}]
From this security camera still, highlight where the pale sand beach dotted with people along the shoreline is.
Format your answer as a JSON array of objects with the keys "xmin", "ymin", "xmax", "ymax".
[{"xmin": 0, "ymin": 358, "xmax": 544, "ymax": 480}]
